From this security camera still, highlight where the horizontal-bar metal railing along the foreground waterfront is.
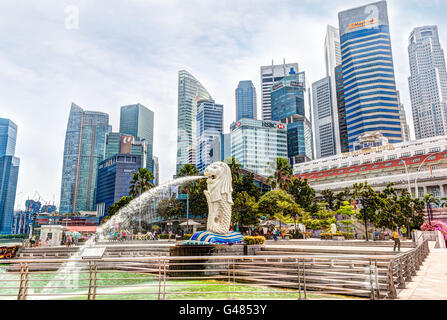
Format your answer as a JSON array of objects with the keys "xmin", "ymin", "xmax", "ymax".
[{"xmin": 0, "ymin": 241, "xmax": 429, "ymax": 300}]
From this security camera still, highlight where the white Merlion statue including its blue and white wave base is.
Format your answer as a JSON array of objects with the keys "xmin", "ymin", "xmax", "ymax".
[{"xmin": 183, "ymin": 162, "xmax": 244, "ymax": 245}]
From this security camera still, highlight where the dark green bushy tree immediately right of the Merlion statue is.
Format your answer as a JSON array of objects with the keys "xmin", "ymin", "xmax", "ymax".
[{"xmin": 231, "ymin": 191, "xmax": 259, "ymax": 232}]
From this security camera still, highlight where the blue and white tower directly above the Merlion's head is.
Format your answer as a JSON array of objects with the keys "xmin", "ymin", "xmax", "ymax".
[{"xmin": 196, "ymin": 100, "xmax": 223, "ymax": 172}]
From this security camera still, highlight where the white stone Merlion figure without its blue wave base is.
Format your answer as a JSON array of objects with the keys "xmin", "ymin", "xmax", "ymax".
[{"xmin": 204, "ymin": 162, "xmax": 233, "ymax": 234}]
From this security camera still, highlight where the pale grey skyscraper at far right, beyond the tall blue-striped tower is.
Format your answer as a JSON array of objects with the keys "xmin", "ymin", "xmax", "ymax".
[{"xmin": 408, "ymin": 26, "xmax": 447, "ymax": 139}]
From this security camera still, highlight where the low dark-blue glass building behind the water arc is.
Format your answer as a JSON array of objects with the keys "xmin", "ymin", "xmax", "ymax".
[{"xmin": 96, "ymin": 154, "xmax": 142, "ymax": 217}]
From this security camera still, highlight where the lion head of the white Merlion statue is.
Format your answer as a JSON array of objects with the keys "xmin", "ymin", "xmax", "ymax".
[{"xmin": 204, "ymin": 162, "xmax": 233, "ymax": 203}]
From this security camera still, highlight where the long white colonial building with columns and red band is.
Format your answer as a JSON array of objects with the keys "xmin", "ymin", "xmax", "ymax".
[{"xmin": 293, "ymin": 136, "xmax": 447, "ymax": 198}]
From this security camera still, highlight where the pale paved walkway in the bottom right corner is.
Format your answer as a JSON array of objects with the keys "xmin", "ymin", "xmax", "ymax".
[{"xmin": 397, "ymin": 241, "xmax": 447, "ymax": 300}]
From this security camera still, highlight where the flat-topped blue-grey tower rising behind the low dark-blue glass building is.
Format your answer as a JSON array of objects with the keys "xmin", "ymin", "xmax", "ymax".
[{"xmin": 120, "ymin": 103, "xmax": 154, "ymax": 173}]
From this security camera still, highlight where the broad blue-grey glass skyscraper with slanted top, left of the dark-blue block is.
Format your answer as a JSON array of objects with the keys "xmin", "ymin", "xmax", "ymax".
[{"xmin": 59, "ymin": 103, "xmax": 109, "ymax": 213}]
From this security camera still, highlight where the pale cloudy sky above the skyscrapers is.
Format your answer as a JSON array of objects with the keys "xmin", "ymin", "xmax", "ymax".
[{"xmin": 0, "ymin": 0, "xmax": 447, "ymax": 208}]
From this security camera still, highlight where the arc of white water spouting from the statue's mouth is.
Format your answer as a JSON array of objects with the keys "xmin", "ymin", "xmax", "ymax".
[{"xmin": 36, "ymin": 176, "xmax": 205, "ymax": 299}]
